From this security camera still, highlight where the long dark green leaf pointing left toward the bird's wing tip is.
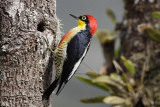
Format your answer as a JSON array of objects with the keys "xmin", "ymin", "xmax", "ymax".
[{"xmin": 76, "ymin": 76, "xmax": 113, "ymax": 93}]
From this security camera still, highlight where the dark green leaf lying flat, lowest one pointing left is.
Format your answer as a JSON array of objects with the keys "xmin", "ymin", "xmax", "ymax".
[{"xmin": 81, "ymin": 96, "xmax": 105, "ymax": 103}]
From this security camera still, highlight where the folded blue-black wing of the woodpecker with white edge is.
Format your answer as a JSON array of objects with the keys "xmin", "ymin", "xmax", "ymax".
[{"xmin": 56, "ymin": 31, "xmax": 91, "ymax": 95}]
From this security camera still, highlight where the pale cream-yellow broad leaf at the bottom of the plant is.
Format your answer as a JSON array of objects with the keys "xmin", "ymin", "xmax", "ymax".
[{"xmin": 103, "ymin": 96, "xmax": 131, "ymax": 105}]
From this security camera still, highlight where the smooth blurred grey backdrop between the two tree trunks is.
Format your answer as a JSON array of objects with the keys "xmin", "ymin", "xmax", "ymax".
[{"xmin": 52, "ymin": 0, "xmax": 124, "ymax": 107}]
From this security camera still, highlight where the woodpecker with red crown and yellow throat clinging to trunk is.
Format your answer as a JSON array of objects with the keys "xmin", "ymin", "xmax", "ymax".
[{"xmin": 42, "ymin": 14, "xmax": 97, "ymax": 100}]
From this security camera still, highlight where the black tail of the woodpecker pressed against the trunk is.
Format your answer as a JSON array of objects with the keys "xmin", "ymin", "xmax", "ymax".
[{"xmin": 42, "ymin": 79, "xmax": 58, "ymax": 100}]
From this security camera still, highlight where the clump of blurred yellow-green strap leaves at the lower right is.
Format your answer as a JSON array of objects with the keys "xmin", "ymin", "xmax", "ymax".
[{"xmin": 77, "ymin": 57, "xmax": 136, "ymax": 106}]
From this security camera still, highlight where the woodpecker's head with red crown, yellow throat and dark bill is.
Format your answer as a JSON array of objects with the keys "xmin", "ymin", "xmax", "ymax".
[{"xmin": 70, "ymin": 14, "xmax": 97, "ymax": 36}]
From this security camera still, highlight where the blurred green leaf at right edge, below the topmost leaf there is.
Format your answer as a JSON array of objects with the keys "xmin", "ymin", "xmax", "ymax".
[{"xmin": 144, "ymin": 28, "xmax": 160, "ymax": 43}]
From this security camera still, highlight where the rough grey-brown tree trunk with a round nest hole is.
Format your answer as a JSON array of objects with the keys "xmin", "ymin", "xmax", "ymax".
[{"xmin": 0, "ymin": 0, "xmax": 57, "ymax": 107}]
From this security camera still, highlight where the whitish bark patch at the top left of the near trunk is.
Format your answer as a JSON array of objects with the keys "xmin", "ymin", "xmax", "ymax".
[{"xmin": 7, "ymin": 0, "xmax": 24, "ymax": 20}]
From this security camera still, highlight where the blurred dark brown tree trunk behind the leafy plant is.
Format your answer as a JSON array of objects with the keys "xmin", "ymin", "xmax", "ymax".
[{"xmin": 117, "ymin": 0, "xmax": 160, "ymax": 107}]
